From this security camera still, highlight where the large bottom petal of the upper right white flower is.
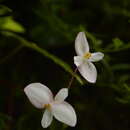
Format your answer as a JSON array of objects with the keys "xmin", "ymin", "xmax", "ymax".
[{"xmin": 78, "ymin": 61, "xmax": 97, "ymax": 83}]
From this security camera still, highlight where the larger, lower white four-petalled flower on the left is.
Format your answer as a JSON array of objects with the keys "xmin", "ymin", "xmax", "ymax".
[{"xmin": 24, "ymin": 83, "xmax": 77, "ymax": 128}]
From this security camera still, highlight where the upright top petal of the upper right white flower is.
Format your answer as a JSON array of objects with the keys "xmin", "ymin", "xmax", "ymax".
[{"xmin": 75, "ymin": 32, "xmax": 89, "ymax": 56}]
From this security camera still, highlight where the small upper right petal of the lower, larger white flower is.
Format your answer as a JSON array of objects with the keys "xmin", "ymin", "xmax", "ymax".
[{"xmin": 55, "ymin": 88, "xmax": 68, "ymax": 102}]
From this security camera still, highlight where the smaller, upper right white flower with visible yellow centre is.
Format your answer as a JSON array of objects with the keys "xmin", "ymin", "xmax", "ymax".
[{"xmin": 74, "ymin": 32, "xmax": 104, "ymax": 83}]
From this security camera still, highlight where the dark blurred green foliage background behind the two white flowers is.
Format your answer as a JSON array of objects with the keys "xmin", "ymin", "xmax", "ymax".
[{"xmin": 0, "ymin": 0, "xmax": 130, "ymax": 130}]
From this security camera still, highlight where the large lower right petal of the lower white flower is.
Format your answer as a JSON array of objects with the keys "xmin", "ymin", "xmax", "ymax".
[{"xmin": 52, "ymin": 102, "xmax": 77, "ymax": 127}]
